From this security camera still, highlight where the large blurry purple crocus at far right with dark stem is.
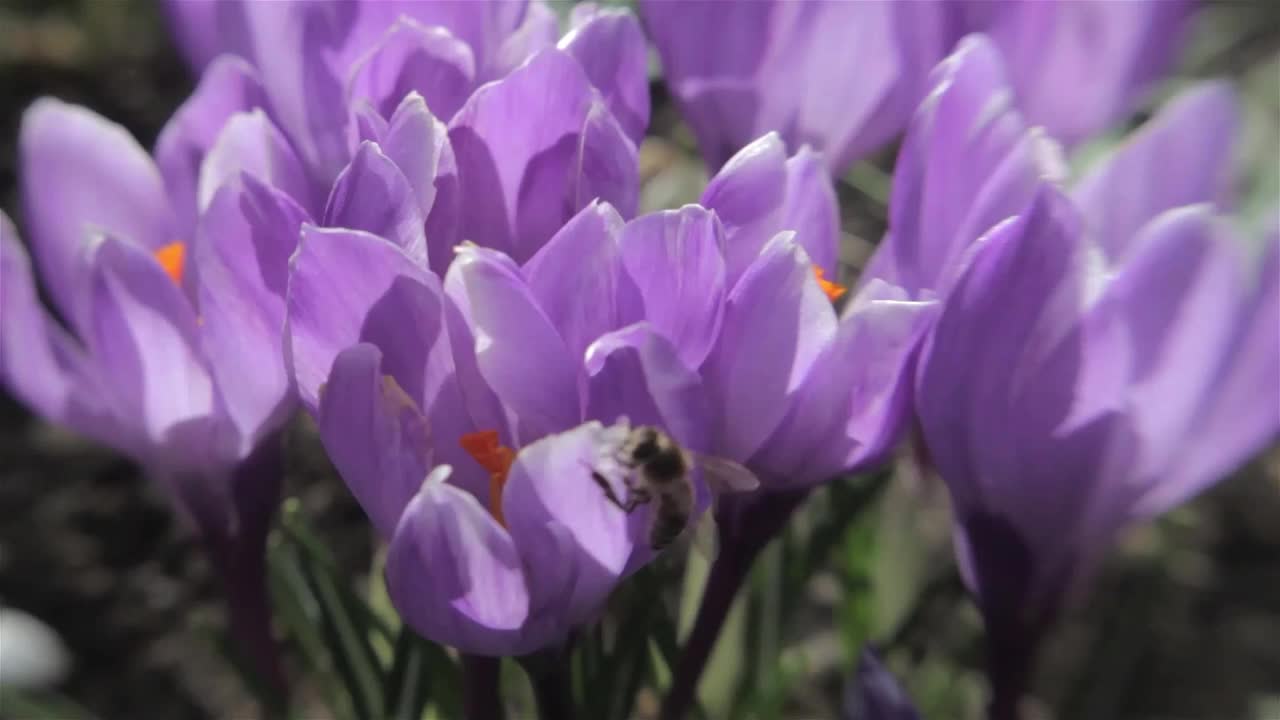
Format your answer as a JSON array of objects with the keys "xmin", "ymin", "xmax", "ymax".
[{"xmin": 868, "ymin": 33, "xmax": 1280, "ymax": 717}]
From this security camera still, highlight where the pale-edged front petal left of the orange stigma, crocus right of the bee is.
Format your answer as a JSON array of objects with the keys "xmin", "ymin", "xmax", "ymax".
[{"xmin": 704, "ymin": 233, "xmax": 837, "ymax": 461}]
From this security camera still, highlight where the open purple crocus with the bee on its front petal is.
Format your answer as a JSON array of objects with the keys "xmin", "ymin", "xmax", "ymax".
[{"xmin": 289, "ymin": 202, "xmax": 747, "ymax": 655}]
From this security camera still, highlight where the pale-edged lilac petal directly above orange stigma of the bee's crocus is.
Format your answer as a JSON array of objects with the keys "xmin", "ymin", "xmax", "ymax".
[{"xmin": 449, "ymin": 246, "xmax": 584, "ymax": 445}]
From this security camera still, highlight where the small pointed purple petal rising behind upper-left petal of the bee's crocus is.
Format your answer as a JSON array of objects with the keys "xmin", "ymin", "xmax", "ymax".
[{"xmin": 324, "ymin": 142, "xmax": 426, "ymax": 266}]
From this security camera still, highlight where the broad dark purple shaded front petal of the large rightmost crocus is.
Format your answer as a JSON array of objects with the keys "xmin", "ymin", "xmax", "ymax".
[{"xmin": 916, "ymin": 186, "xmax": 1119, "ymax": 584}]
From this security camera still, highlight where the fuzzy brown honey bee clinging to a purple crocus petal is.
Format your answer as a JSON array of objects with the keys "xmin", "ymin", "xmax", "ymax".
[{"xmin": 591, "ymin": 421, "xmax": 759, "ymax": 551}]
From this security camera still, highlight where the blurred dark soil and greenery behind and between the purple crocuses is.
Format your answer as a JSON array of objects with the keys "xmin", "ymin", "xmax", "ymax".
[{"xmin": 0, "ymin": 0, "xmax": 1280, "ymax": 720}]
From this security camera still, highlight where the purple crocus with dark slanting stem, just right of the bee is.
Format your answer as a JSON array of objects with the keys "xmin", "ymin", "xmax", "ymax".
[{"xmin": 650, "ymin": 133, "xmax": 936, "ymax": 717}]
